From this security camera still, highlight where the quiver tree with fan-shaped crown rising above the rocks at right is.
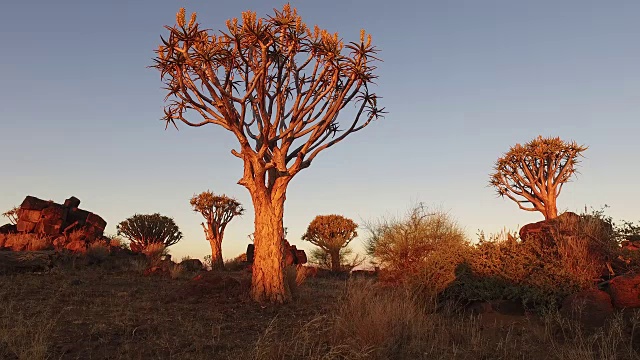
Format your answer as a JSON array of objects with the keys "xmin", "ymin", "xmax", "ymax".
[{"xmin": 489, "ymin": 136, "xmax": 587, "ymax": 219}]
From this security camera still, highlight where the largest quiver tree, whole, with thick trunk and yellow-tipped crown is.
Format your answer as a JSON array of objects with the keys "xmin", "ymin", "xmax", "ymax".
[{"xmin": 153, "ymin": 4, "xmax": 383, "ymax": 302}]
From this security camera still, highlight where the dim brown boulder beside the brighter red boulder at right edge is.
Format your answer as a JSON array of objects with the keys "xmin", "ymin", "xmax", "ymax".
[{"xmin": 560, "ymin": 289, "xmax": 613, "ymax": 327}]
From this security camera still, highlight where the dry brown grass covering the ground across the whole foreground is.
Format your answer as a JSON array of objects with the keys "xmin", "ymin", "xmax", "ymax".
[{"xmin": 0, "ymin": 267, "xmax": 640, "ymax": 360}]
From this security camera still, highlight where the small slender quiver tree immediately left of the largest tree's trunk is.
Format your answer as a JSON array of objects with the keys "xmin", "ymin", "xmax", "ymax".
[{"xmin": 190, "ymin": 191, "xmax": 244, "ymax": 270}]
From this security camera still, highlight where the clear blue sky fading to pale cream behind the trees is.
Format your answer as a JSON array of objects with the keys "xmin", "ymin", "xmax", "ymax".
[{"xmin": 0, "ymin": 0, "xmax": 640, "ymax": 258}]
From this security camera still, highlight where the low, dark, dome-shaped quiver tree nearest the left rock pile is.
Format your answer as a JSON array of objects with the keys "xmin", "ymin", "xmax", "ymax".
[{"xmin": 116, "ymin": 213, "xmax": 182, "ymax": 252}]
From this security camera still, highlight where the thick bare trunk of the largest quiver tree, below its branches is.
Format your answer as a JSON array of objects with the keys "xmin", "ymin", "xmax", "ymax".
[{"xmin": 249, "ymin": 187, "xmax": 291, "ymax": 303}]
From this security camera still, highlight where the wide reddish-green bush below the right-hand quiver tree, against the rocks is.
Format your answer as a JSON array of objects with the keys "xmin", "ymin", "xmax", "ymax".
[{"xmin": 444, "ymin": 214, "xmax": 619, "ymax": 309}]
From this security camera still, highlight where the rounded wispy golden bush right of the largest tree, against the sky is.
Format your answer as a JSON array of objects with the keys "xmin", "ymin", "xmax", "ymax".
[{"xmin": 367, "ymin": 204, "xmax": 469, "ymax": 295}]
